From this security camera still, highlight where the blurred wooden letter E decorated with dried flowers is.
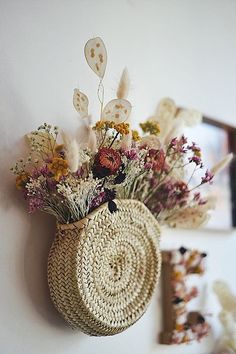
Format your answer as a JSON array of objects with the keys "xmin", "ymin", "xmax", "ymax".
[{"xmin": 160, "ymin": 247, "xmax": 210, "ymax": 344}]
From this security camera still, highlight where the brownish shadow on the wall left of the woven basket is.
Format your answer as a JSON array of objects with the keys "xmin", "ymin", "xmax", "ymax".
[{"xmin": 24, "ymin": 213, "xmax": 72, "ymax": 331}]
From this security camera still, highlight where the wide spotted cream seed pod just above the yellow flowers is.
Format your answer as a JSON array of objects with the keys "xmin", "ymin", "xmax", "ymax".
[{"xmin": 102, "ymin": 99, "xmax": 132, "ymax": 123}]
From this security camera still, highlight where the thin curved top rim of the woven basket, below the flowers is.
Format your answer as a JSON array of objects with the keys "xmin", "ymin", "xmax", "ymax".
[{"xmin": 57, "ymin": 199, "xmax": 159, "ymax": 230}]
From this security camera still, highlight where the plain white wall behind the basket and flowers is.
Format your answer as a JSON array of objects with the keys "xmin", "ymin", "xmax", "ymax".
[{"xmin": 0, "ymin": 0, "xmax": 236, "ymax": 354}]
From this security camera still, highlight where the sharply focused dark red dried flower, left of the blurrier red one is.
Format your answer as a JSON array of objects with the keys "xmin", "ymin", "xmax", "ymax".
[{"xmin": 93, "ymin": 147, "xmax": 121, "ymax": 178}]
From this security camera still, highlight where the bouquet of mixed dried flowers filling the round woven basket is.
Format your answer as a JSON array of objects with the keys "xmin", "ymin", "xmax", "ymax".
[{"xmin": 12, "ymin": 38, "xmax": 231, "ymax": 228}]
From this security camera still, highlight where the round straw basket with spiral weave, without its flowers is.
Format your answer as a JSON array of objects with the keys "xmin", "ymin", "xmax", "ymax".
[{"xmin": 48, "ymin": 200, "xmax": 161, "ymax": 336}]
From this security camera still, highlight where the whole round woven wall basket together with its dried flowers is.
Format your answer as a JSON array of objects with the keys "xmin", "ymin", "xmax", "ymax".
[{"xmin": 12, "ymin": 38, "xmax": 232, "ymax": 336}]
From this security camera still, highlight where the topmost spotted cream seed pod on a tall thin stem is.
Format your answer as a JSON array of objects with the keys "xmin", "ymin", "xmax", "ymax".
[{"xmin": 84, "ymin": 37, "xmax": 107, "ymax": 79}]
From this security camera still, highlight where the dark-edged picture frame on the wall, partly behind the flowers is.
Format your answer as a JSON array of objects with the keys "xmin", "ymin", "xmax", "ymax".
[{"xmin": 184, "ymin": 116, "xmax": 236, "ymax": 231}]
